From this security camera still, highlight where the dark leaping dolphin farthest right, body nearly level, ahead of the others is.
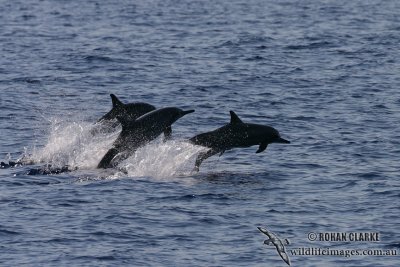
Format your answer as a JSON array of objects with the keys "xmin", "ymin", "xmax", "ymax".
[{"xmin": 189, "ymin": 111, "xmax": 290, "ymax": 171}]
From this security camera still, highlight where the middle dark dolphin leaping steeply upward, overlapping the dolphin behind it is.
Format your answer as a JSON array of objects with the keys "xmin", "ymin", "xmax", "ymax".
[{"xmin": 97, "ymin": 107, "xmax": 194, "ymax": 169}]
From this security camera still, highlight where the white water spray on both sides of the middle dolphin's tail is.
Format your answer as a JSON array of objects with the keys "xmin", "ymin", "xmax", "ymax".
[{"xmin": 24, "ymin": 119, "xmax": 205, "ymax": 179}]
